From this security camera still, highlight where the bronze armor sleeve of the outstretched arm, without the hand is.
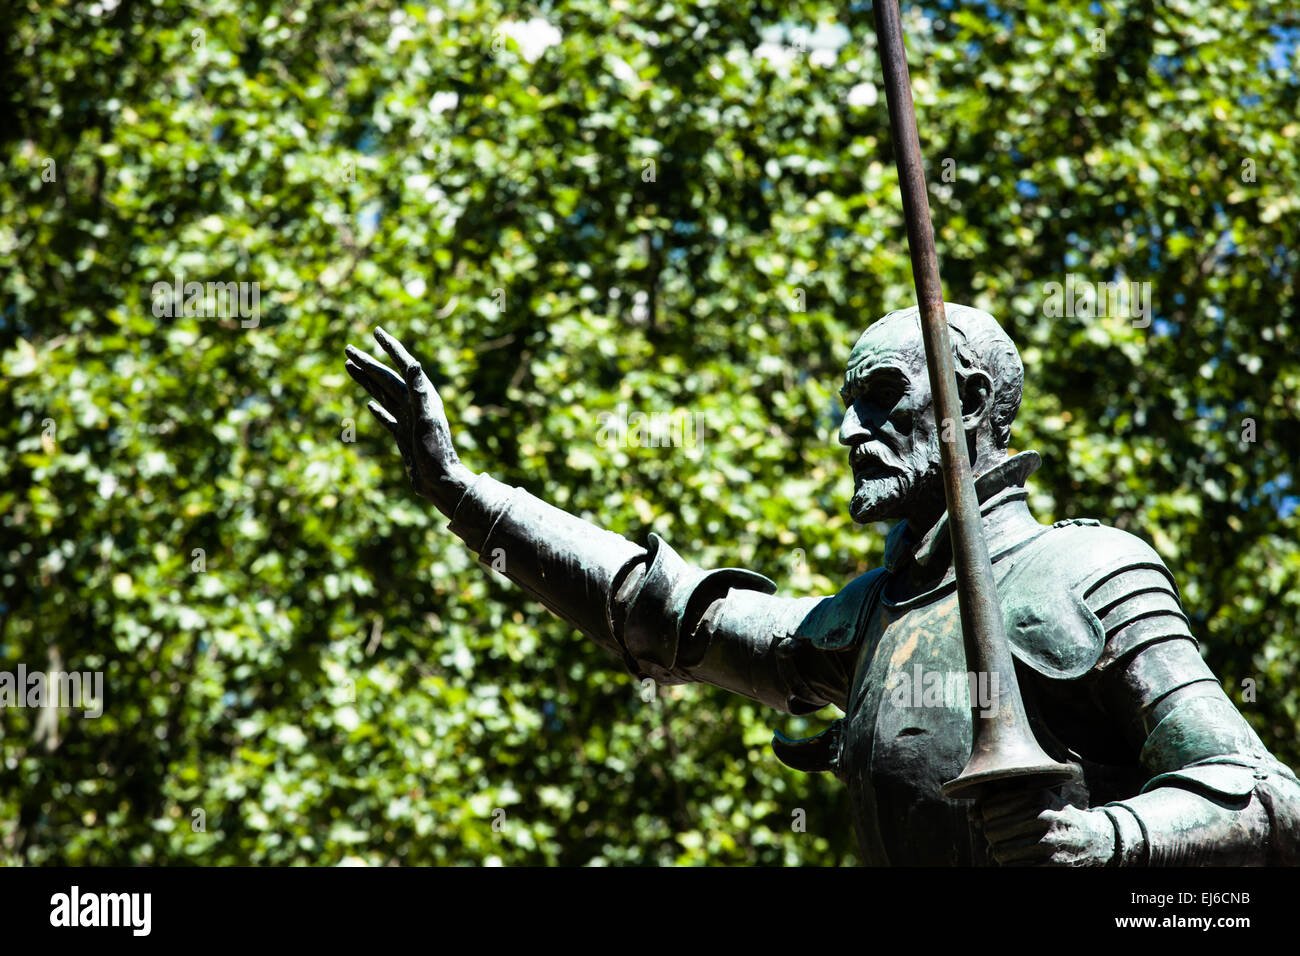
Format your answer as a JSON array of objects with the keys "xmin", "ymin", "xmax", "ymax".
[{"xmin": 450, "ymin": 475, "xmax": 848, "ymax": 713}]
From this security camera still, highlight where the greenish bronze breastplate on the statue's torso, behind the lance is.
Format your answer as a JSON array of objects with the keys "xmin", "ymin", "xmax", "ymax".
[{"xmin": 839, "ymin": 522, "xmax": 1159, "ymax": 866}]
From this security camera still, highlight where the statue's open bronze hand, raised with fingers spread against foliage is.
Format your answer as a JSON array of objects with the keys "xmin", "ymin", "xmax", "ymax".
[{"xmin": 345, "ymin": 328, "xmax": 475, "ymax": 516}]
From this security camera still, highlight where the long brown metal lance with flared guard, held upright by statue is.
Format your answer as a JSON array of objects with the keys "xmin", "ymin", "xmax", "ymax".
[{"xmin": 872, "ymin": 0, "xmax": 1076, "ymax": 796}]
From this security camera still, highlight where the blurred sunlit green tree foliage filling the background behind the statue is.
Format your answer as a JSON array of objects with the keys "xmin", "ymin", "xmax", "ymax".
[{"xmin": 0, "ymin": 0, "xmax": 1300, "ymax": 864}]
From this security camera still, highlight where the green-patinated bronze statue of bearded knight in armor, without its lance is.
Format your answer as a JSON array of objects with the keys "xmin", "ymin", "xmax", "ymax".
[{"xmin": 347, "ymin": 304, "xmax": 1300, "ymax": 866}]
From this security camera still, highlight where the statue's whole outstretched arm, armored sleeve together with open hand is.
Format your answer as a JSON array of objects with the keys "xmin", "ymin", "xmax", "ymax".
[{"xmin": 346, "ymin": 329, "xmax": 846, "ymax": 713}]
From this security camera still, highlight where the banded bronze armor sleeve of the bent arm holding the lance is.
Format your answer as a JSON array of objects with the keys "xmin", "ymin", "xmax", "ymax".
[{"xmin": 1084, "ymin": 529, "xmax": 1300, "ymax": 866}]
